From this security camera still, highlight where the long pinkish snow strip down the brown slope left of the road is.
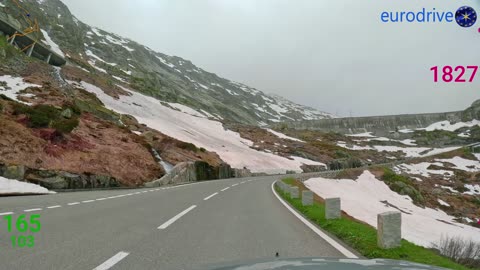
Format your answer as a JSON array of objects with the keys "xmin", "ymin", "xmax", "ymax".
[{"xmin": 73, "ymin": 82, "xmax": 316, "ymax": 173}]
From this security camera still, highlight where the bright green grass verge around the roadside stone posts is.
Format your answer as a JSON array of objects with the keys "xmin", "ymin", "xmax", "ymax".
[{"xmin": 275, "ymin": 178, "xmax": 470, "ymax": 269}]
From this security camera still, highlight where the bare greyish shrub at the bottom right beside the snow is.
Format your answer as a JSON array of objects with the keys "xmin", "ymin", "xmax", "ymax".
[{"xmin": 434, "ymin": 236, "xmax": 480, "ymax": 269}]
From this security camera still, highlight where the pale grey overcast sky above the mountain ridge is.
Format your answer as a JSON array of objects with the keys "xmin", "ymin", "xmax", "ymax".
[{"xmin": 62, "ymin": 0, "xmax": 480, "ymax": 116}]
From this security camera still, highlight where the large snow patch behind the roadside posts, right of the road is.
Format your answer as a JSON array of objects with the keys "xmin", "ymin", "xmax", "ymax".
[{"xmin": 305, "ymin": 171, "xmax": 480, "ymax": 247}]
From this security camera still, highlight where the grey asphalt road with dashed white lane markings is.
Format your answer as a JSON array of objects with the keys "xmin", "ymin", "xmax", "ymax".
[{"xmin": 0, "ymin": 177, "xmax": 344, "ymax": 270}]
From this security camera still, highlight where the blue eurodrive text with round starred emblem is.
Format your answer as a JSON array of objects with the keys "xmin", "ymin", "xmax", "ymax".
[{"xmin": 380, "ymin": 6, "xmax": 480, "ymax": 31}]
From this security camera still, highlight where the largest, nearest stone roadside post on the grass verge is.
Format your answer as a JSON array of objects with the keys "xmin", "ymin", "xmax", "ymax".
[{"xmin": 377, "ymin": 211, "xmax": 402, "ymax": 249}]
